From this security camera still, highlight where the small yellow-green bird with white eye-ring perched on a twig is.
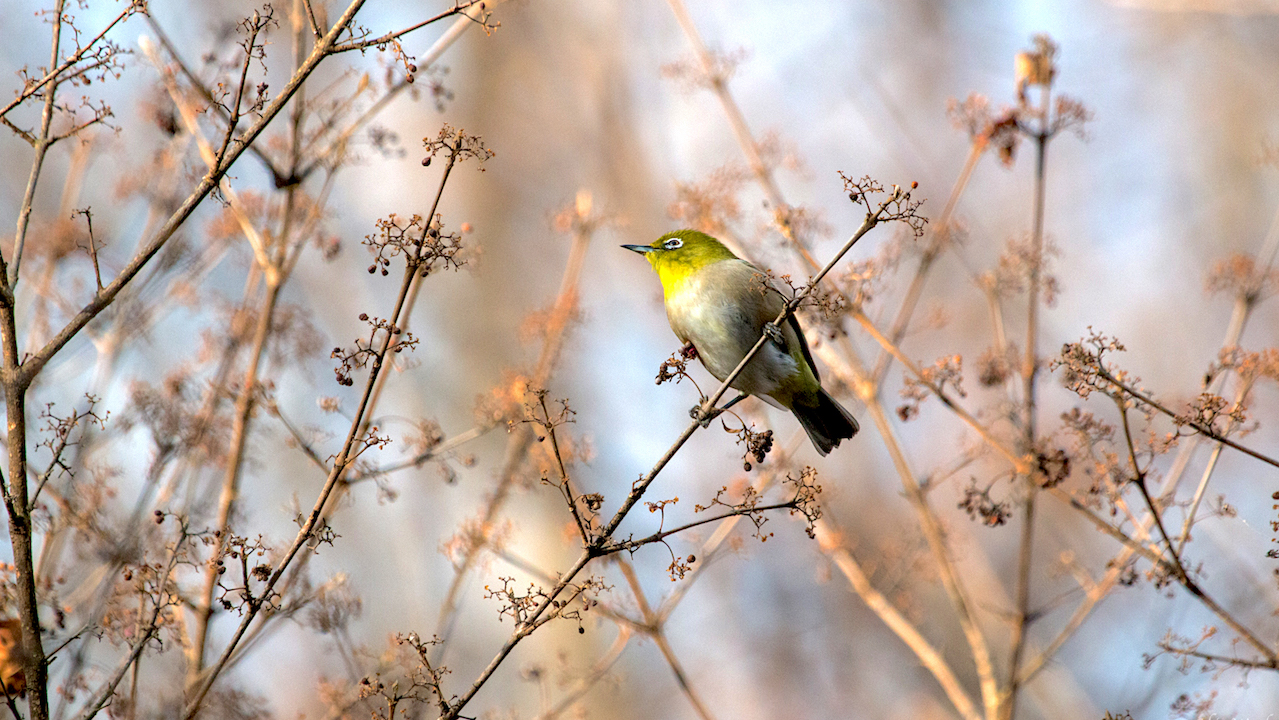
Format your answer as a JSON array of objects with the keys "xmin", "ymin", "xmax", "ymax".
[{"xmin": 622, "ymin": 230, "xmax": 857, "ymax": 455}]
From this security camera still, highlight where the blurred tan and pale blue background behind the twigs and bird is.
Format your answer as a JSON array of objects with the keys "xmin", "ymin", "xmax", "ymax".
[{"xmin": 0, "ymin": 0, "xmax": 1279, "ymax": 719}]
